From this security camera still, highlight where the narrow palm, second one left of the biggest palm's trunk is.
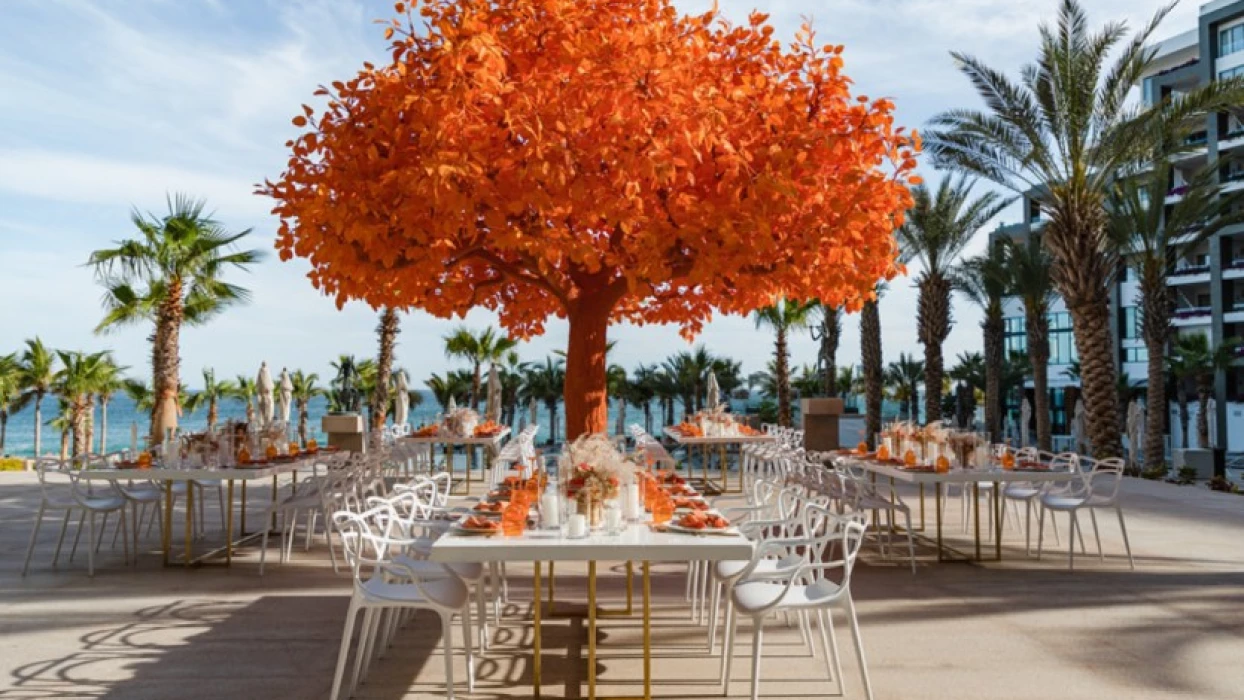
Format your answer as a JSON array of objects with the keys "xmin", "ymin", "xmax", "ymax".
[{"xmin": 955, "ymin": 245, "xmax": 1010, "ymax": 443}]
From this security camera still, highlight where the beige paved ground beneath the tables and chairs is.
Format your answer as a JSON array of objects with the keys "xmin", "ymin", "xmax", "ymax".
[{"xmin": 0, "ymin": 474, "xmax": 1244, "ymax": 700}]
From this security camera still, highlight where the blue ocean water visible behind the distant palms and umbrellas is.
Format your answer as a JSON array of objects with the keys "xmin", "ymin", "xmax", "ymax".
[{"xmin": 0, "ymin": 390, "xmax": 721, "ymax": 458}]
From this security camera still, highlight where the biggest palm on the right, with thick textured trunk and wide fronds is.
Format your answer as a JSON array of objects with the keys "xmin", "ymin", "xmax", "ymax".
[{"xmin": 924, "ymin": 0, "xmax": 1244, "ymax": 458}]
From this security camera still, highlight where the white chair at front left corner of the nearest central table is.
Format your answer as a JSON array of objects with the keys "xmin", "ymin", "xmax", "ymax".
[{"xmin": 331, "ymin": 506, "xmax": 475, "ymax": 700}]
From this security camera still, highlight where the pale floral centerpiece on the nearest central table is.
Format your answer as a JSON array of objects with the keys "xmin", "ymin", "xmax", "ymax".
[{"xmin": 559, "ymin": 433, "xmax": 636, "ymax": 527}]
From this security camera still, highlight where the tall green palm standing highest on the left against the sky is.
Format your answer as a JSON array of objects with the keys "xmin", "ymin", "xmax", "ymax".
[{"xmin": 88, "ymin": 194, "xmax": 262, "ymax": 443}]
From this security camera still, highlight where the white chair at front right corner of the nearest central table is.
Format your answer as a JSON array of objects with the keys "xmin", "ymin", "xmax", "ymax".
[{"xmin": 722, "ymin": 504, "xmax": 872, "ymax": 700}]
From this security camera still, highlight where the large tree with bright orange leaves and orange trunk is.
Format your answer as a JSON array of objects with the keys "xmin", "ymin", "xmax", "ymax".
[{"xmin": 260, "ymin": 0, "xmax": 918, "ymax": 438}]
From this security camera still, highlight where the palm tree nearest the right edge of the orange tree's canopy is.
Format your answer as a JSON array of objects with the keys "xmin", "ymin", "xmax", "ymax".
[{"xmin": 897, "ymin": 177, "xmax": 1008, "ymax": 421}]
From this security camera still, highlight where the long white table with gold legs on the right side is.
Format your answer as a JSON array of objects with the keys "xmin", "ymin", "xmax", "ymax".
[{"xmin": 835, "ymin": 454, "xmax": 1084, "ymax": 562}]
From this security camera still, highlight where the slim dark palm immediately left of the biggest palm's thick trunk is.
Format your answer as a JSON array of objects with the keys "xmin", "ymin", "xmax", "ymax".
[{"xmin": 1005, "ymin": 234, "xmax": 1054, "ymax": 451}]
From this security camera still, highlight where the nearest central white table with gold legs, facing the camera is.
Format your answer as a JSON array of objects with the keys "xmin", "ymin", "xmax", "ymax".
[{"xmin": 430, "ymin": 523, "xmax": 751, "ymax": 700}]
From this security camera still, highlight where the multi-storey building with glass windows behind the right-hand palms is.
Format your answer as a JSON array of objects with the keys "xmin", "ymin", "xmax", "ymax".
[{"xmin": 990, "ymin": 0, "xmax": 1244, "ymax": 453}]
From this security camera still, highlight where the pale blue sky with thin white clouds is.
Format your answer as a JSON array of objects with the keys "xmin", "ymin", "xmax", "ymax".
[{"xmin": 0, "ymin": 0, "xmax": 1198, "ymax": 387}]
